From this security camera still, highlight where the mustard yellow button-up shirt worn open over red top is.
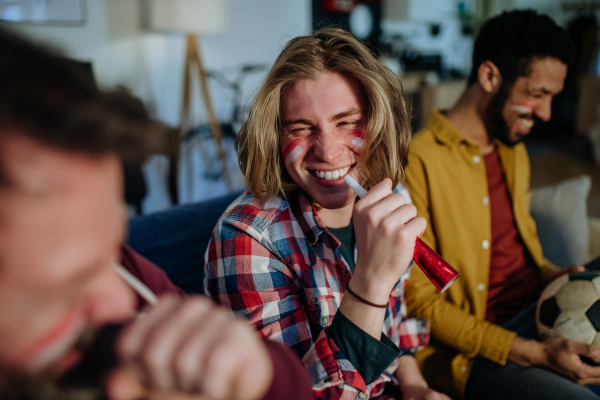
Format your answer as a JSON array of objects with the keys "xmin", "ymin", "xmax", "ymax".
[{"xmin": 405, "ymin": 111, "xmax": 557, "ymax": 397}]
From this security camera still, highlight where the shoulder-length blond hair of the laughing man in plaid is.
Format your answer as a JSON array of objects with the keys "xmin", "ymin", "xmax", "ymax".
[{"xmin": 235, "ymin": 28, "xmax": 411, "ymax": 198}]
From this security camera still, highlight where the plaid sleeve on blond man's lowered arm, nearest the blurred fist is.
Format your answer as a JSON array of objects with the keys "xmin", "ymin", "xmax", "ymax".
[{"xmin": 205, "ymin": 222, "xmax": 390, "ymax": 399}]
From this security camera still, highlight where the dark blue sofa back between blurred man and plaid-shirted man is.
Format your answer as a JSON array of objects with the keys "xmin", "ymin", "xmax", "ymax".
[{"xmin": 128, "ymin": 192, "xmax": 242, "ymax": 293}]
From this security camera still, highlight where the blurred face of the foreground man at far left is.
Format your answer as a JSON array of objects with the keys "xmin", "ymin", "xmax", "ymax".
[{"xmin": 0, "ymin": 135, "xmax": 134, "ymax": 374}]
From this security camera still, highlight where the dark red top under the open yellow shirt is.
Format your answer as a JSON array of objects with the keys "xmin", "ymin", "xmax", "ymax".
[{"xmin": 484, "ymin": 151, "xmax": 541, "ymax": 324}]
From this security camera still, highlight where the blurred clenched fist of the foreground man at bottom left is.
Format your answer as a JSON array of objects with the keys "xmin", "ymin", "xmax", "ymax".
[{"xmin": 106, "ymin": 296, "xmax": 273, "ymax": 400}]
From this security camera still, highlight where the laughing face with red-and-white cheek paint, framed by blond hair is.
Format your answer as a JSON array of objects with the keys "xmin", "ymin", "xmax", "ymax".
[{"xmin": 281, "ymin": 72, "xmax": 366, "ymax": 209}]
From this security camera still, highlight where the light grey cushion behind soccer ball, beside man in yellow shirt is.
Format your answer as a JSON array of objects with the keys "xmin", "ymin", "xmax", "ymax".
[{"xmin": 531, "ymin": 175, "xmax": 592, "ymax": 267}]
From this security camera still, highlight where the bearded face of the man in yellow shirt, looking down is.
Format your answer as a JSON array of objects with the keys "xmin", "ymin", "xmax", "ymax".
[{"xmin": 486, "ymin": 57, "xmax": 567, "ymax": 146}]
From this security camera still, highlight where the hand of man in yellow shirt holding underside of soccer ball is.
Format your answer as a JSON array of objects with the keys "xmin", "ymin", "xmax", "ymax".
[{"xmin": 508, "ymin": 336, "xmax": 600, "ymax": 385}]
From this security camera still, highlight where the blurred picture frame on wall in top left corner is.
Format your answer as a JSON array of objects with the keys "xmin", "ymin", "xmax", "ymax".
[{"xmin": 0, "ymin": 0, "xmax": 87, "ymax": 26}]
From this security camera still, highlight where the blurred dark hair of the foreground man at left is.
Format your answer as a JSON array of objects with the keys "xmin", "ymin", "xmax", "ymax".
[{"xmin": 0, "ymin": 24, "xmax": 166, "ymax": 182}]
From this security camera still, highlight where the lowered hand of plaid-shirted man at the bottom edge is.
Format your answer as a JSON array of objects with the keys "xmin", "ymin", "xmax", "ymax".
[{"xmin": 394, "ymin": 355, "xmax": 450, "ymax": 400}]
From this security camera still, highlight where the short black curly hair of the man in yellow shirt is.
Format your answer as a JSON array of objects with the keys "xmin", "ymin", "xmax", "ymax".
[{"xmin": 468, "ymin": 10, "xmax": 574, "ymax": 87}]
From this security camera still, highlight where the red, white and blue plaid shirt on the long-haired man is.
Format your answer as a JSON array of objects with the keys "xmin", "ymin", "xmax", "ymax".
[{"xmin": 204, "ymin": 191, "xmax": 429, "ymax": 399}]
